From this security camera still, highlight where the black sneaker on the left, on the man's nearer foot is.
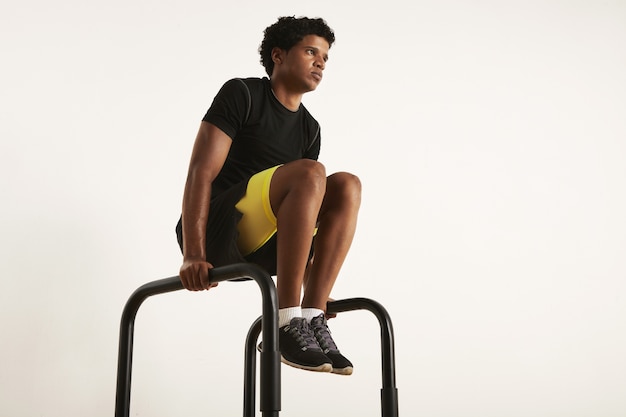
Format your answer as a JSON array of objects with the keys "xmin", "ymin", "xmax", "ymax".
[{"xmin": 278, "ymin": 317, "xmax": 333, "ymax": 372}]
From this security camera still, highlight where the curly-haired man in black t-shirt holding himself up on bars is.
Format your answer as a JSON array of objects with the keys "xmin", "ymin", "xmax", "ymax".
[{"xmin": 177, "ymin": 17, "xmax": 361, "ymax": 375}]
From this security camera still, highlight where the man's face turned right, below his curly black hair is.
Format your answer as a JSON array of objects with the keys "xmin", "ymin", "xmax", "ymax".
[{"xmin": 273, "ymin": 35, "xmax": 330, "ymax": 93}]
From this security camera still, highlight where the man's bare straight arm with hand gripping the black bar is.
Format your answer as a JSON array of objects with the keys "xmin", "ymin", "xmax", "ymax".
[{"xmin": 180, "ymin": 122, "xmax": 232, "ymax": 291}]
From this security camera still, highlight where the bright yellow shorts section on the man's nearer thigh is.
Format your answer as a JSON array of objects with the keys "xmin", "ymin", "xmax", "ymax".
[{"xmin": 235, "ymin": 165, "xmax": 280, "ymax": 256}]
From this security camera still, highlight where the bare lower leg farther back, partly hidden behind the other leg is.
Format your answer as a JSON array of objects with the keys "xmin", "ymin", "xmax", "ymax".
[{"xmin": 302, "ymin": 172, "xmax": 361, "ymax": 311}]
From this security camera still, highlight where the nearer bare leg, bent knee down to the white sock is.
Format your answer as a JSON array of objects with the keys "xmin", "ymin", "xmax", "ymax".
[{"xmin": 270, "ymin": 159, "xmax": 326, "ymax": 308}]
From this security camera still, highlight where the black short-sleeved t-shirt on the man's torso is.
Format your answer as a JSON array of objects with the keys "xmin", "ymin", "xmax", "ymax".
[{"xmin": 202, "ymin": 78, "xmax": 320, "ymax": 198}]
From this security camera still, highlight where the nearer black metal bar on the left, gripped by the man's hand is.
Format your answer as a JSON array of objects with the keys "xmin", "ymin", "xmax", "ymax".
[{"xmin": 115, "ymin": 263, "xmax": 280, "ymax": 417}]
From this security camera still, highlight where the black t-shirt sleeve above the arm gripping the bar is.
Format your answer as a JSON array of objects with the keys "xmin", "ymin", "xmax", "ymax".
[{"xmin": 202, "ymin": 78, "xmax": 250, "ymax": 139}]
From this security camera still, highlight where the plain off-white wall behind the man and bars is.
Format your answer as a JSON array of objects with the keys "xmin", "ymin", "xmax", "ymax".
[{"xmin": 0, "ymin": 0, "xmax": 626, "ymax": 417}]
